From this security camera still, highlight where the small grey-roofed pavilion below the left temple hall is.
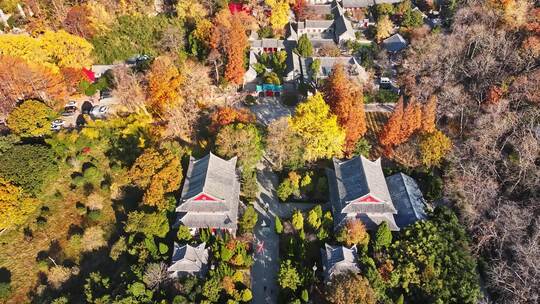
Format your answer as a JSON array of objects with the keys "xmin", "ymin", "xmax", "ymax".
[{"xmin": 167, "ymin": 243, "xmax": 208, "ymax": 279}]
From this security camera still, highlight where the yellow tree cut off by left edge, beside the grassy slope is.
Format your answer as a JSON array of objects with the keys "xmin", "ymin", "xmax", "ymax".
[{"xmin": 0, "ymin": 177, "xmax": 39, "ymax": 230}]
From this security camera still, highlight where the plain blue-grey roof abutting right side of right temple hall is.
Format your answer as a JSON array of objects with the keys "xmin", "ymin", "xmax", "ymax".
[{"xmin": 386, "ymin": 173, "xmax": 427, "ymax": 228}]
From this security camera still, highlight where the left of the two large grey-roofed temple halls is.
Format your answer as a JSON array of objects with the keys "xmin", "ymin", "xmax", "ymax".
[{"xmin": 175, "ymin": 153, "xmax": 240, "ymax": 235}]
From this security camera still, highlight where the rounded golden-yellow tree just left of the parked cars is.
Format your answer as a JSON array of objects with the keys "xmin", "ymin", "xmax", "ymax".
[{"xmin": 7, "ymin": 100, "xmax": 56, "ymax": 137}]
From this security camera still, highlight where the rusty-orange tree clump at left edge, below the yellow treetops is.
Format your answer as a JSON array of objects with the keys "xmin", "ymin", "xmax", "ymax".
[{"xmin": 0, "ymin": 56, "xmax": 67, "ymax": 116}]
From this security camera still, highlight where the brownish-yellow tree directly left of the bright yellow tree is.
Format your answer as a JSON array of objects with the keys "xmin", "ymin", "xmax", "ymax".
[{"xmin": 266, "ymin": 117, "xmax": 304, "ymax": 171}]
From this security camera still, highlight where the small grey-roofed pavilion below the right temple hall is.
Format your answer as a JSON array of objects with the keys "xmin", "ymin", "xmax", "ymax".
[{"xmin": 321, "ymin": 244, "xmax": 360, "ymax": 282}]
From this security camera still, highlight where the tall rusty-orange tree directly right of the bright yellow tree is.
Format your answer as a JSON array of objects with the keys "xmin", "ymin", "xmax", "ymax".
[{"xmin": 324, "ymin": 64, "xmax": 367, "ymax": 154}]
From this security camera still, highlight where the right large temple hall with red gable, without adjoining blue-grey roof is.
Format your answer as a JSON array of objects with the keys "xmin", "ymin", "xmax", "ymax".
[{"xmin": 327, "ymin": 156, "xmax": 399, "ymax": 231}]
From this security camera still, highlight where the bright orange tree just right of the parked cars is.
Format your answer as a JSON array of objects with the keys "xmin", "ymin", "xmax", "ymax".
[{"xmin": 147, "ymin": 56, "xmax": 184, "ymax": 116}]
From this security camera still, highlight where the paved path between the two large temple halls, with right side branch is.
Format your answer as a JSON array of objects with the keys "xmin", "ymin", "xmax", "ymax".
[{"xmin": 251, "ymin": 160, "xmax": 315, "ymax": 304}]
